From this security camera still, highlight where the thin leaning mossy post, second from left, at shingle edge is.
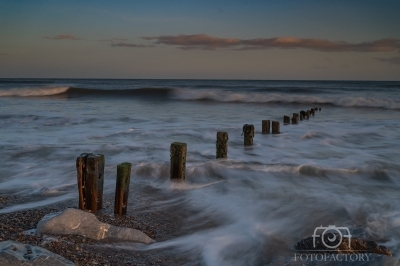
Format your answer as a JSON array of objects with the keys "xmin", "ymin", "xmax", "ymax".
[{"xmin": 114, "ymin": 162, "xmax": 132, "ymax": 215}]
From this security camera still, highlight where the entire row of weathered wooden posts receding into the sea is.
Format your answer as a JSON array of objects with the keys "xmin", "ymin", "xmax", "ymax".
[{"xmin": 76, "ymin": 108, "xmax": 321, "ymax": 215}]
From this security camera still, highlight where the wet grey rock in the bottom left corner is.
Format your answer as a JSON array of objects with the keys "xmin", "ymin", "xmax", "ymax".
[{"xmin": 0, "ymin": 241, "xmax": 75, "ymax": 266}]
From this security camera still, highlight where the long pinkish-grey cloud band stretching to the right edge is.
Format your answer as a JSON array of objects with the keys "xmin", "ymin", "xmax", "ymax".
[{"xmin": 142, "ymin": 34, "xmax": 400, "ymax": 52}]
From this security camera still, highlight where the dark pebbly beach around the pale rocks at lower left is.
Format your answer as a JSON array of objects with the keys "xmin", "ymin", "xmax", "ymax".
[{"xmin": 0, "ymin": 188, "xmax": 198, "ymax": 265}]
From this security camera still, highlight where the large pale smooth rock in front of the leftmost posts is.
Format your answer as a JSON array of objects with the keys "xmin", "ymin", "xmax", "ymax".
[{"xmin": 36, "ymin": 209, "xmax": 155, "ymax": 244}]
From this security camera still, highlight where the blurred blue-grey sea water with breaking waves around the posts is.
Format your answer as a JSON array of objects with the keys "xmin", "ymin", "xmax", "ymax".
[{"xmin": 0, "ymin": 79, "xmax": 400, "ymax": 265}]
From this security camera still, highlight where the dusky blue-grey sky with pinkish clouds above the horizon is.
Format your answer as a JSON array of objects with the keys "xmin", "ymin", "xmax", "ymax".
[{"xmin": 0, "ymin": 0, "xmax": 400, "ymax": 80}]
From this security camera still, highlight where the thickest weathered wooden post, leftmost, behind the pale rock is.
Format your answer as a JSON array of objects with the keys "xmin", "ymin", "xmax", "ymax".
[{"xmin": 76, "ymin": 153, "xmax": 104, "ymax": 212}]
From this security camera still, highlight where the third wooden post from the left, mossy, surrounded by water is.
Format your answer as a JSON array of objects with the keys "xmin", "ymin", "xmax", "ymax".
[{"xmin": 170, "ymin": 142, "xmax": 187, "ymax": 181}]
